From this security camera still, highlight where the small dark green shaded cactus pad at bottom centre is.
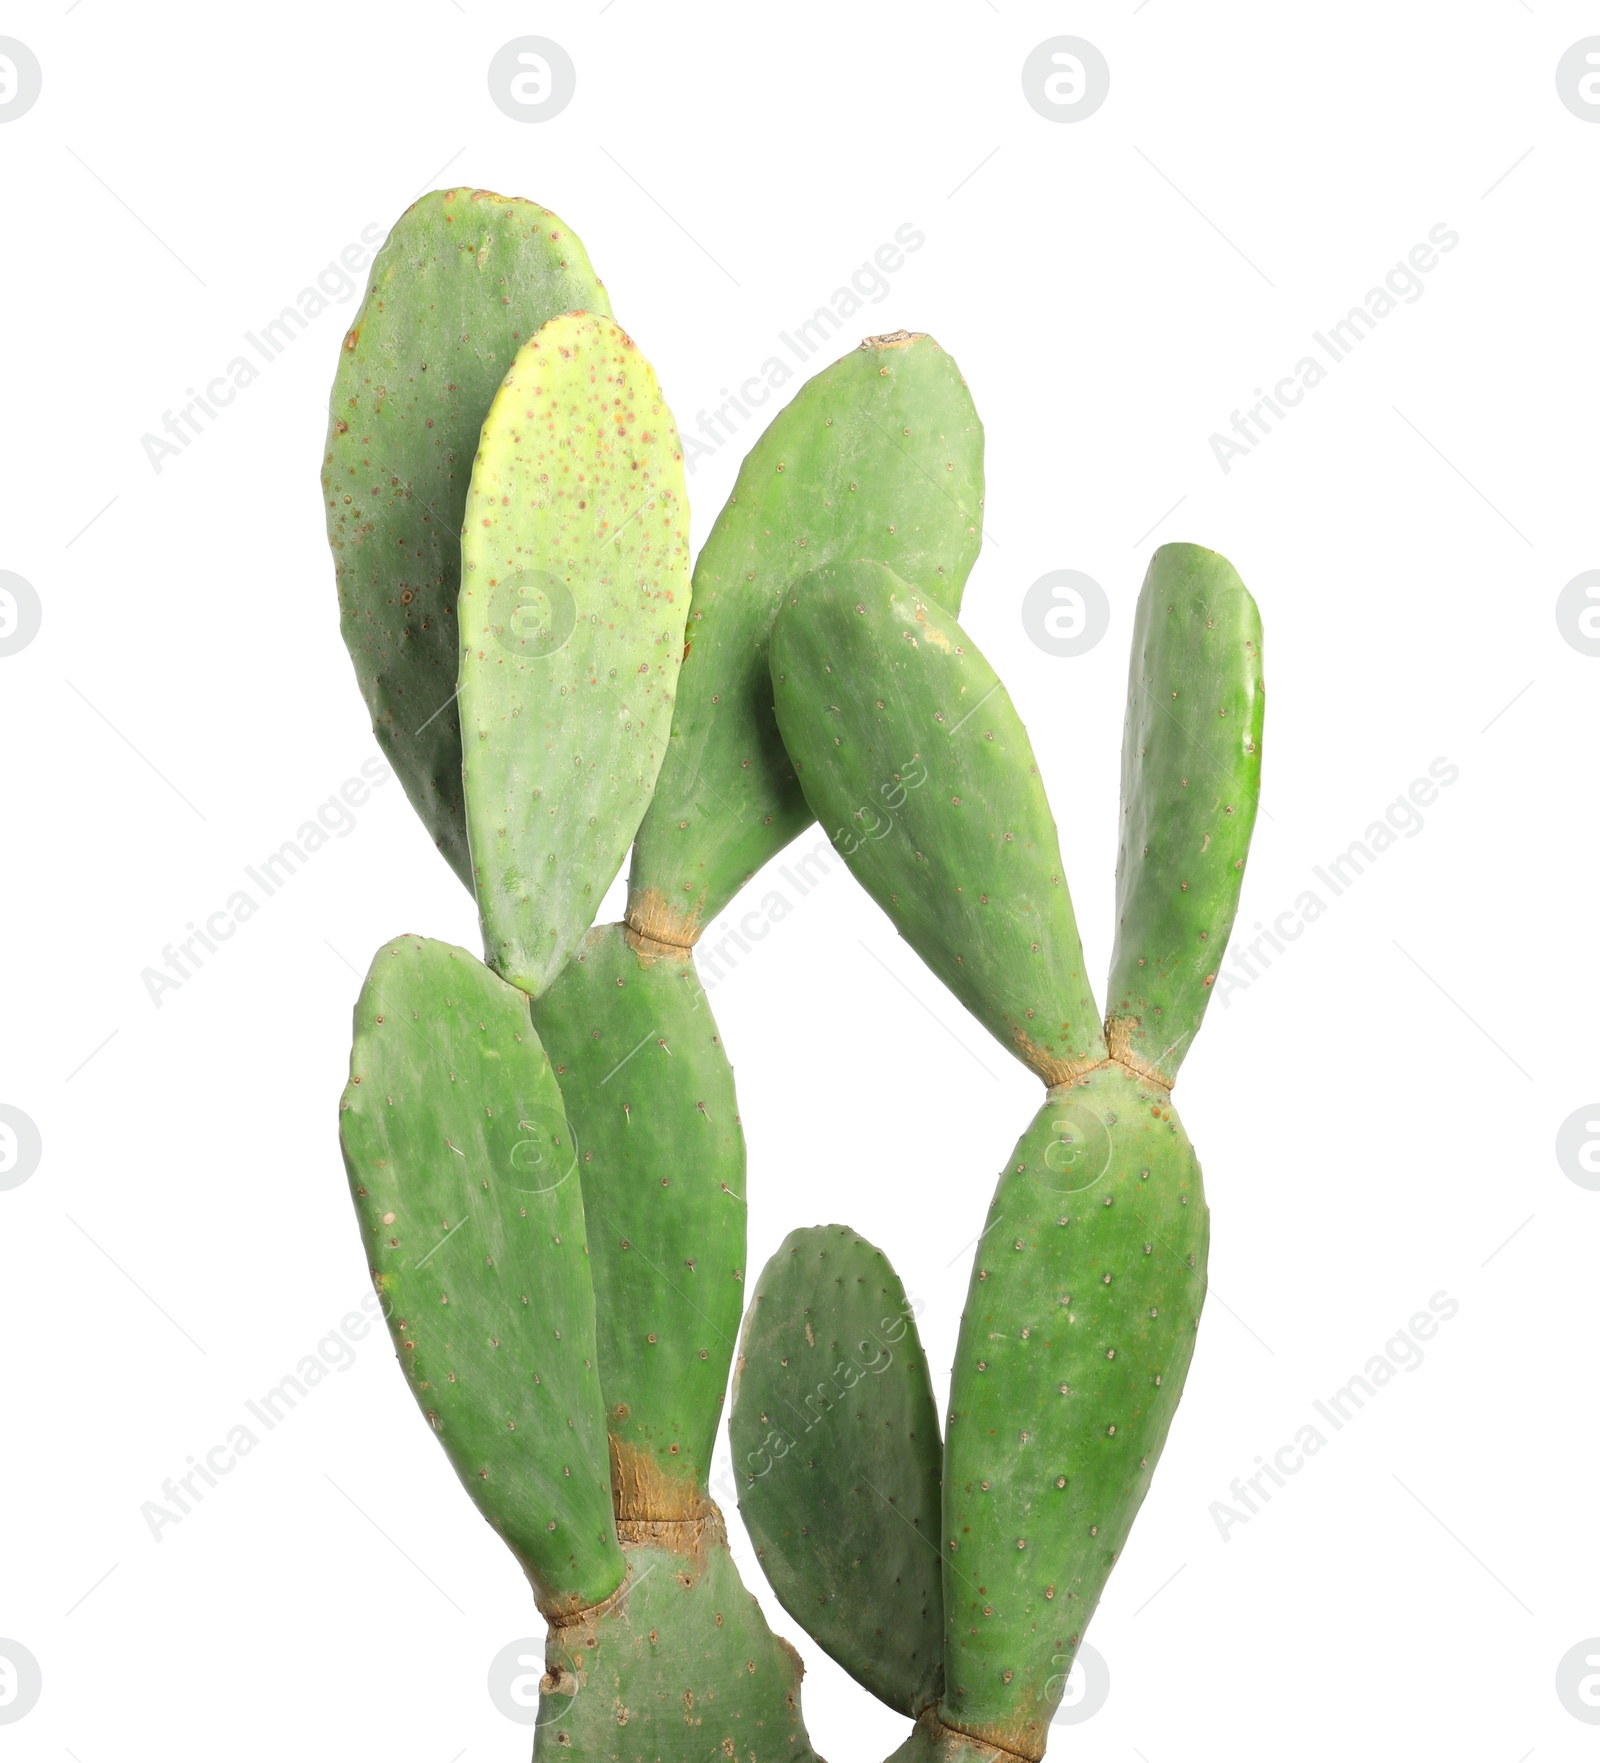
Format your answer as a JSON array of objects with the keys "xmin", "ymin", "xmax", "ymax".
[{"xmin": 730, "ymin": 1225, "xmax": 944, "ymax": 1717}]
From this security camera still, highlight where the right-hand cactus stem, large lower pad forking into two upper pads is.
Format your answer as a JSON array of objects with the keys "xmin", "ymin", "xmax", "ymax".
[{"xmin": 757, "ymin": 545, "xmax": 1263, "ymax": 1759}]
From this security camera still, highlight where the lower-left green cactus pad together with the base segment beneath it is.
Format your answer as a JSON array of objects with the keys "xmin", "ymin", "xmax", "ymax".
[{"xmin": 340, "ymin": 938, "xmax": 812, "ymax": 1763}]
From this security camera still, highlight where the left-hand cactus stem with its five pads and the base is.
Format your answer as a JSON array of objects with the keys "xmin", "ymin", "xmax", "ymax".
[{"xmin": 324, "ymin": 192, "xmax": 981, "ymax": 1763}]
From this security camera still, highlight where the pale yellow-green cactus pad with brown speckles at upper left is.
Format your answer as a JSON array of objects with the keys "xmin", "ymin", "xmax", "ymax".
[{"xmin": 458, "ymin": 312, "xmax": 689, "ymax": 998}]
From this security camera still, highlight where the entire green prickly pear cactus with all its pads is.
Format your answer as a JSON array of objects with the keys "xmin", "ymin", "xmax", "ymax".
[{"xmin": 324, "ymin": 178, "xmax": 1262, "ymax": 1763}]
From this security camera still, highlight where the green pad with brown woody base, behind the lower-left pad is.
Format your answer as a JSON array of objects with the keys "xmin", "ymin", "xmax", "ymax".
[{"xmin": 534, "ymin": 924, "xmax": 745, "ymax": 1518}]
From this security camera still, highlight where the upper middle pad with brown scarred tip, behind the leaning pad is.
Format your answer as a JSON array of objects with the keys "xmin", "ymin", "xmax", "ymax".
[{"xmin": 627, "ymin": 331, "xmax": 983, "ymax": 943}]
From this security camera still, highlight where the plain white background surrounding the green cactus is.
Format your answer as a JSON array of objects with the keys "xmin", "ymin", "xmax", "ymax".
[{"xmin": 0, "ymin": 0, "xmax": 1600, "ymax": 1763}]
